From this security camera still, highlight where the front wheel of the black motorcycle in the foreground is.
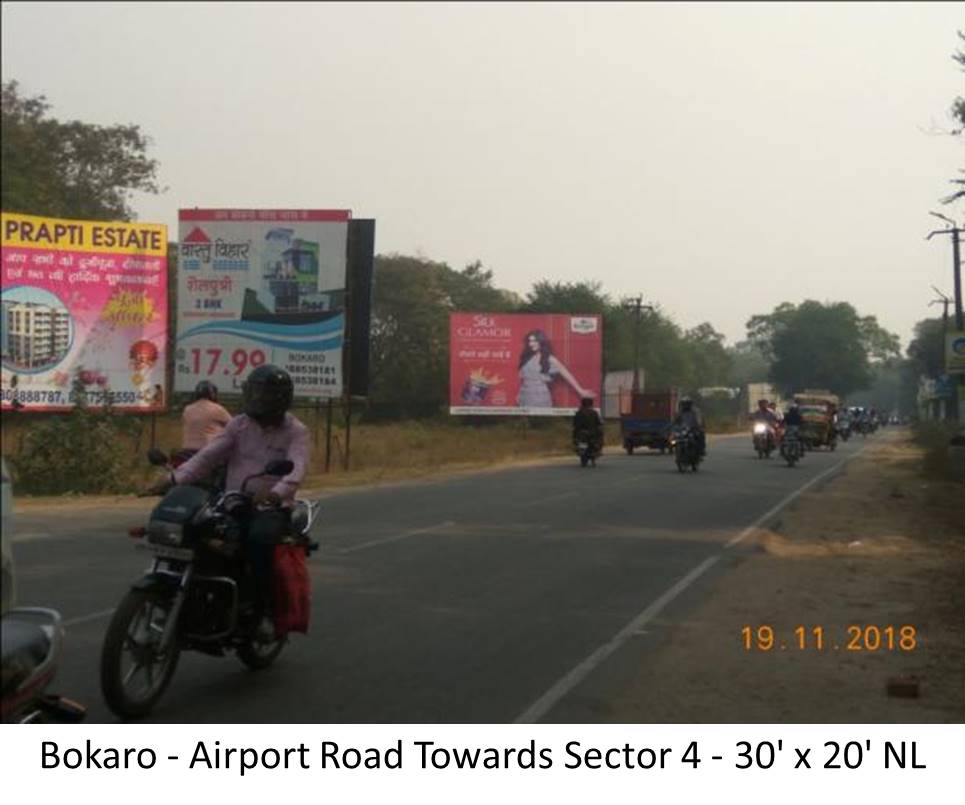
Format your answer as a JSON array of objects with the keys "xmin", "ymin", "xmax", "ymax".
[{"xmin": 101, "ymin": 590, "xmax": 180, "ymax": 718}]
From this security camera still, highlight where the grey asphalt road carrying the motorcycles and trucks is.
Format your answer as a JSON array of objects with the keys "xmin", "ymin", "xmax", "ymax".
[{"xmin": 7, "ymin": 436, "xmax": 868, "ymax": 723}]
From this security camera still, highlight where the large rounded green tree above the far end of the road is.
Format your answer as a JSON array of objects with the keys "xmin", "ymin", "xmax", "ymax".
[{"xmin": 747, "ymin": 299, "xmax": 898, "ymax": 396}]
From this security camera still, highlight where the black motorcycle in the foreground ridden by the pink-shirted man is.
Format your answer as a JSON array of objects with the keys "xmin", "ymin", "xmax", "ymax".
[{"xmin": 100, "ymin": 449, "xmax": 319, "ymax": 718}]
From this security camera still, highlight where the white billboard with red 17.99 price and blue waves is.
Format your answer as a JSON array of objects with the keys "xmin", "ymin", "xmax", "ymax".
[{"xmin": 174, "ymin": 208, "xmax": 350, "ymax": 398}]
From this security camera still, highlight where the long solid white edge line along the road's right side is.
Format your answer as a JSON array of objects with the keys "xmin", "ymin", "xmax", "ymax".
[{"xmin": 515, "ymin": 440, "xmax": 867, "ymax": 724}]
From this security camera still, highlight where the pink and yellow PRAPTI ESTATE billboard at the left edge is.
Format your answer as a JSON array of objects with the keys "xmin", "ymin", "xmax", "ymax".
[{"xmin": 0, "ymin": 212, "xmax": 168, "ymax": 411}]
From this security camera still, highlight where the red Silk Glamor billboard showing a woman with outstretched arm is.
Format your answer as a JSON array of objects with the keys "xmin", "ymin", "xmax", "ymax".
[{"xmin": 449, "ymin": 313, "xmax": 603, "ymax": 416}]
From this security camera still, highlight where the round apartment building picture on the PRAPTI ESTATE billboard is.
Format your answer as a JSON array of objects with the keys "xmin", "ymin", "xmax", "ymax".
[{"xmin": 2, "ymin": 294, "xmax": 71, "ymax": 372}]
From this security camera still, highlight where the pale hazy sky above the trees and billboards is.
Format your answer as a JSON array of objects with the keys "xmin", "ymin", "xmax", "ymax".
[{"xmin": 2, "ymin": 3, "xmax": 965, "ymax": 342}]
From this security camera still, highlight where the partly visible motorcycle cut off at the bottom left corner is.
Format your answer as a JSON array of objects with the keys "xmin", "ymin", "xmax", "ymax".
[{"xmin": 0, "ymin": 607, "xmax": 87, "ymax": 724}]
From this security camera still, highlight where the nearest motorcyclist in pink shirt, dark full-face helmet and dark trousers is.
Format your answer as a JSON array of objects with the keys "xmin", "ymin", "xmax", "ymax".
[{"xmin": 149, "ymin": 364, "xmax": 310, "ymax": 642}]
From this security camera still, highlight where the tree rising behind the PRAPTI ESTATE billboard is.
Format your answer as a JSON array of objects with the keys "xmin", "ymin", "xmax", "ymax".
[{"xmin": 0, "ymin": 81, "xmax": 159, "ymax": 220}]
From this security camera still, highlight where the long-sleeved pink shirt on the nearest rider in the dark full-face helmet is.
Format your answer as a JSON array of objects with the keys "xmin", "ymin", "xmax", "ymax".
[{"xmin": 174, "ymin": 414, "xmax": 310, "ymax": 502}]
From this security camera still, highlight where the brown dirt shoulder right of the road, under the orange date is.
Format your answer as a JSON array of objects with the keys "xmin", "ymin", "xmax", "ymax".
[{"xmin": 609, "ymin": 433, "xmax": 965, "ymax": 723}]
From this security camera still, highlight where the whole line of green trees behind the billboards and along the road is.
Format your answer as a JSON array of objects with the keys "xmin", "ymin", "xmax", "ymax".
[{"xmin": 0, "ymin": 81, "xmax": 948, "ymax": 418}]
